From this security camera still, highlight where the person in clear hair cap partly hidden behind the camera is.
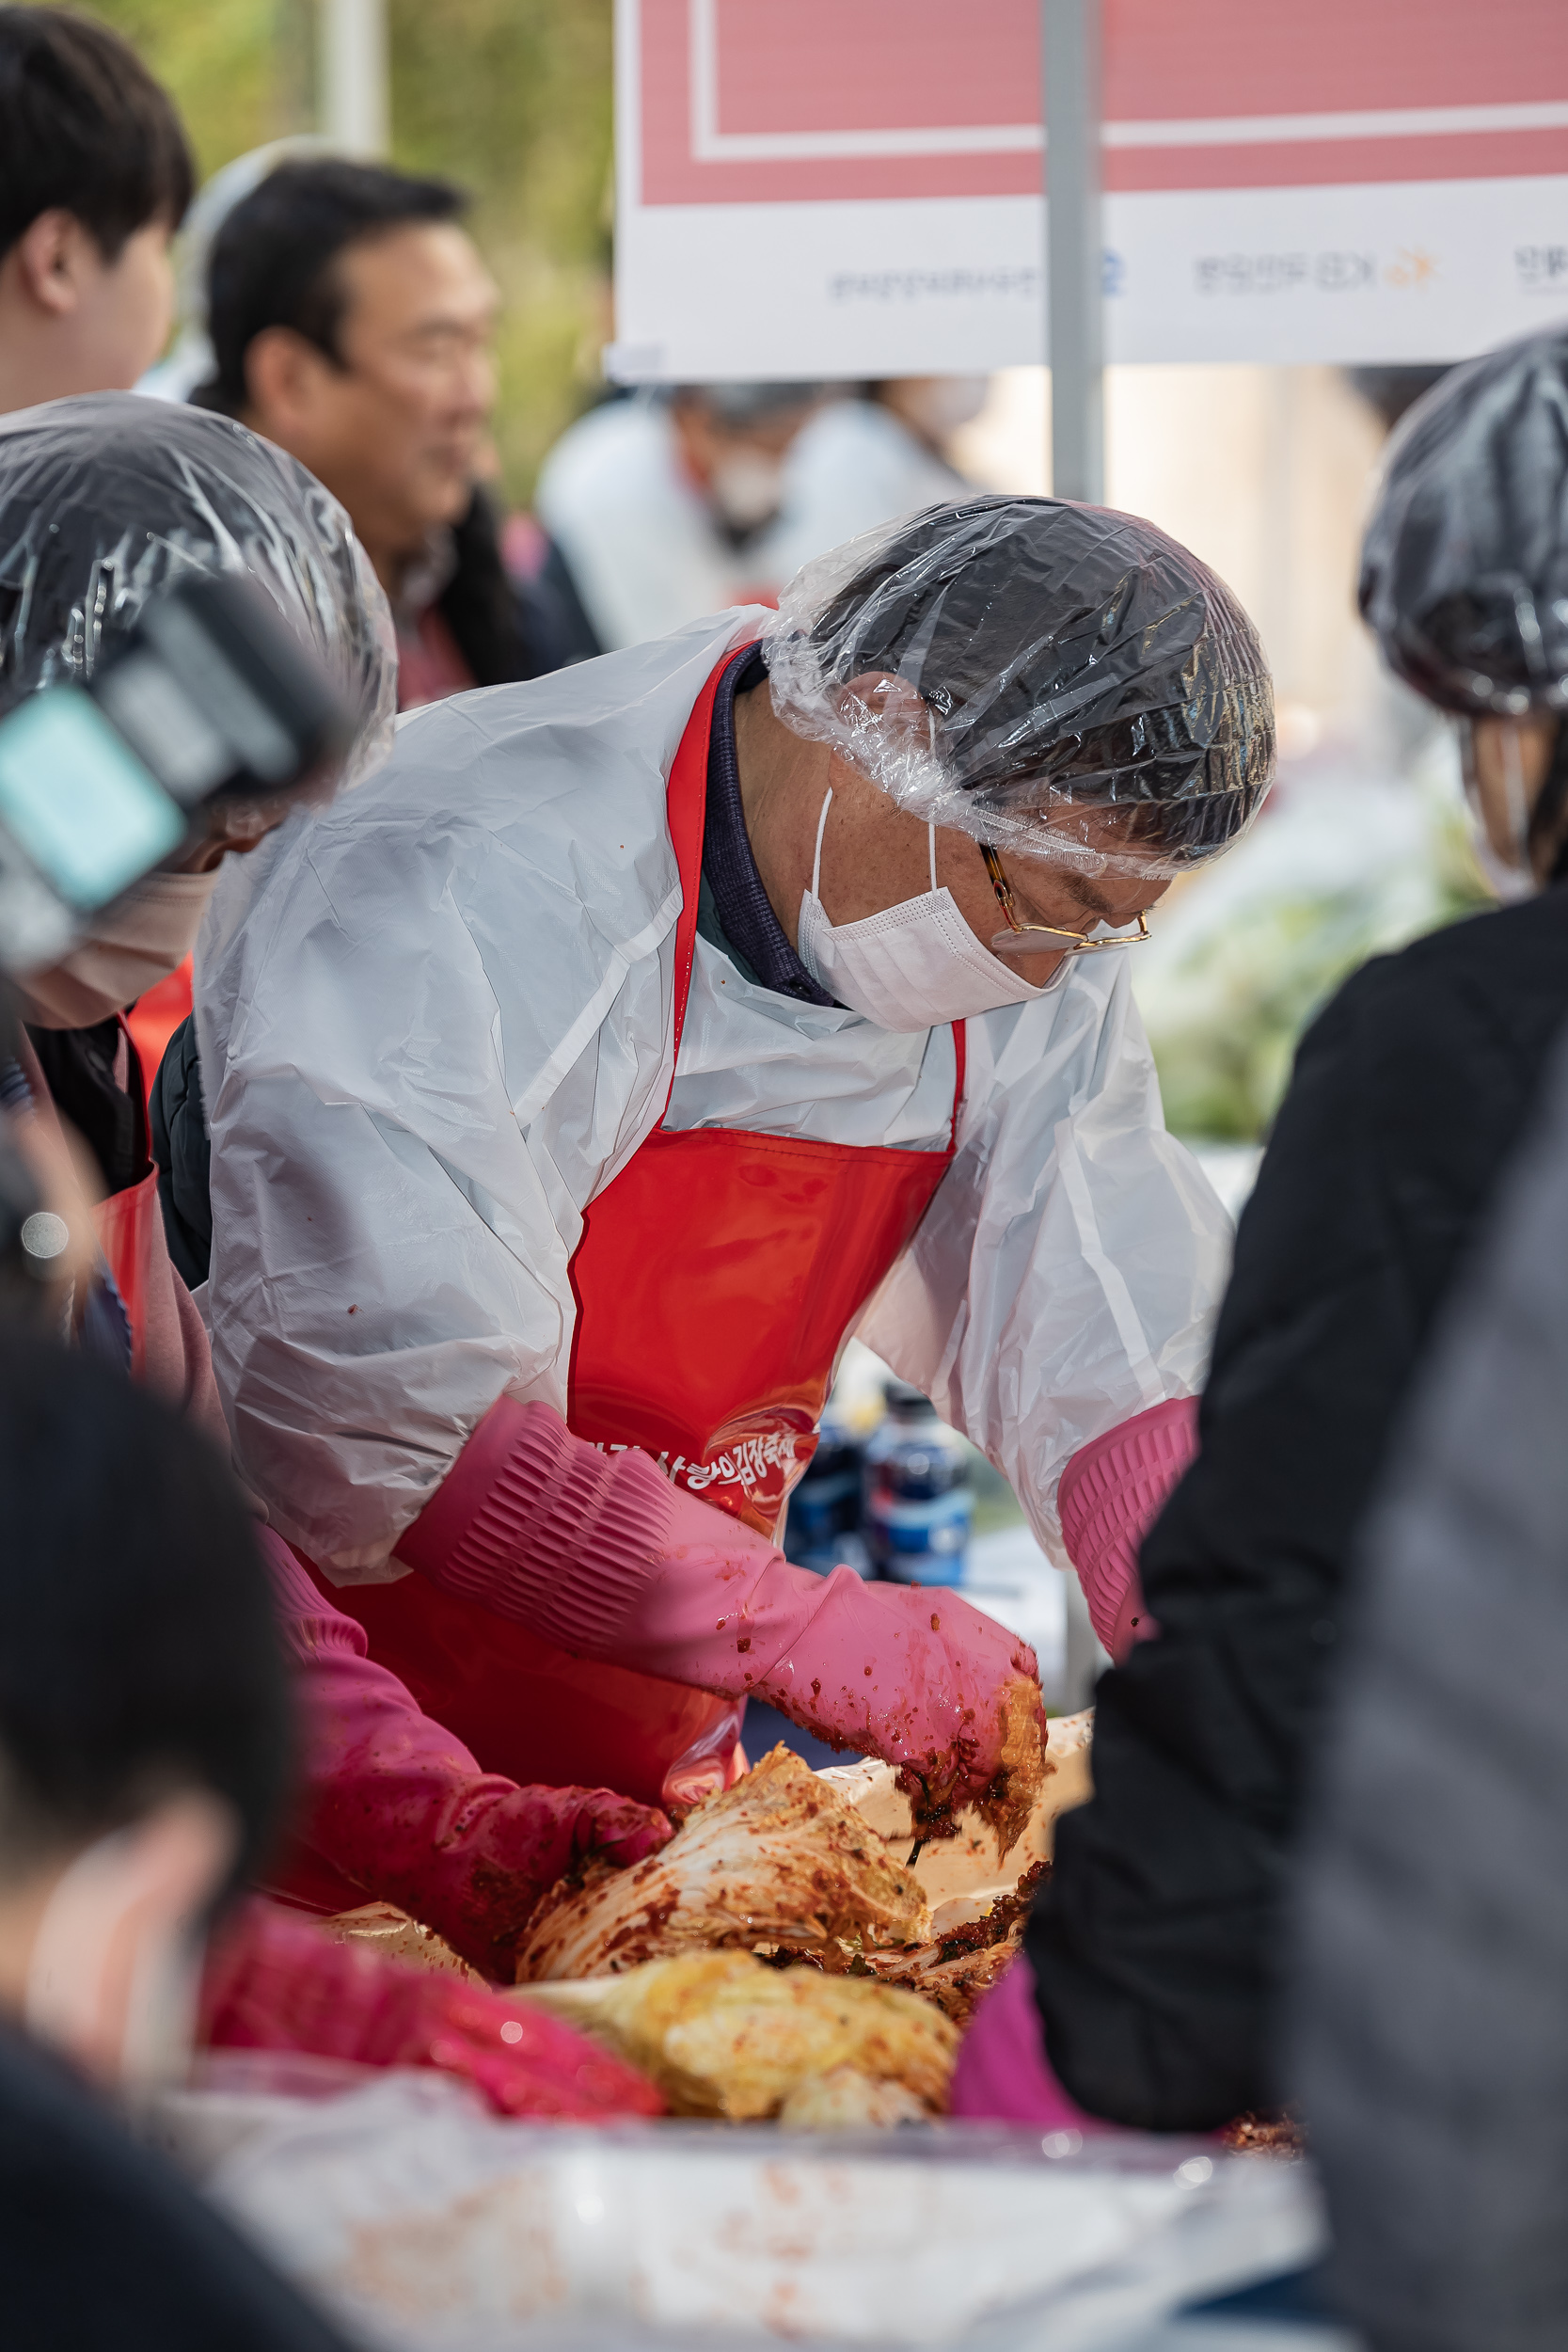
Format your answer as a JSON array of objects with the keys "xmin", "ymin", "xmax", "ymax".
[{"xmin": 0, "ymin": 393, "xmax": 390, "ymax": 1374}]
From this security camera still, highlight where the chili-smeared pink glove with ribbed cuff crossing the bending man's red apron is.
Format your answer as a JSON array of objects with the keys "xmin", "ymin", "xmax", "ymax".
[{"xmin": 397, "ymin": 1397, "xmax": 1044, "ymax": 1809}]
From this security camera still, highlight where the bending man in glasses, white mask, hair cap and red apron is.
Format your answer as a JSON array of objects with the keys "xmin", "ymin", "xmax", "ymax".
[{"xmin": 198, "ymin": 499, "xmax": 1275, "ymax": 1947}]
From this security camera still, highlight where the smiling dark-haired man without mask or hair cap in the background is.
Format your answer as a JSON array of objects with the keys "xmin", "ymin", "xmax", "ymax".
[{"xmin": 193, "ymin": 158, "xmax": 564, "ymax": 710}]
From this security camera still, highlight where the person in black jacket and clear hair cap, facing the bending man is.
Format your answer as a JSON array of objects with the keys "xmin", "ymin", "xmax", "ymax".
[{"xmin": 955, "ymin": 329, "xmax": 1568, "ymax": 2131}]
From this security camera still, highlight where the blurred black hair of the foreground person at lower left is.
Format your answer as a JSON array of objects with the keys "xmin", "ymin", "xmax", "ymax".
[{"xmin": 0, "ymin": 1331, "xmax": 289, "ymax": 1882}]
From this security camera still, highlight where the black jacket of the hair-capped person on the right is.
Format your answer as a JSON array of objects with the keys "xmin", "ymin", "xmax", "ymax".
[{"xmin": 1027, "ymin": 889, "xmax": 1568, "ymax": 2131}]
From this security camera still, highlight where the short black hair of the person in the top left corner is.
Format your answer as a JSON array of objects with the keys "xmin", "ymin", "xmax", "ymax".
[{"xmin": 0, "ymin": 8, "xmax": 195, "ymax": 262}]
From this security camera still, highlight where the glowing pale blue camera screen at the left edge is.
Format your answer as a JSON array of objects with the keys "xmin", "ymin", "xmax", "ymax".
[{"xmin": 0, "ymin": 687, "xmax": 185, "ymax": 911}]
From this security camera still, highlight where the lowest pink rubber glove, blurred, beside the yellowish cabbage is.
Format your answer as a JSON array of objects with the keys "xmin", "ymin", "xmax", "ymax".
[{"xmin": 199, "ymin": 1896, "xmax": 665, "ymax": 2124}]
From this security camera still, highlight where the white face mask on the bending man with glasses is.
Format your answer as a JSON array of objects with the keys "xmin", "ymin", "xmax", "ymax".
[{"xmin": 800, "ymin": 790, "xmax": 1068, "ymax": 1030}]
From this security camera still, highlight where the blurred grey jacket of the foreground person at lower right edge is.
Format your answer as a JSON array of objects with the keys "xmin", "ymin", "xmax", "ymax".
[{"xmin": 1291, "ymin": 1021, "xmax": 1568, "ymax": 2352}]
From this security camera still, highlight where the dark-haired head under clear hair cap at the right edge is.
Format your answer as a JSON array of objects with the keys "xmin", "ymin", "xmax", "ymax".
[{"xmin": 1359, "ymin": 327, "xmax": 1568, "ymax": 718}]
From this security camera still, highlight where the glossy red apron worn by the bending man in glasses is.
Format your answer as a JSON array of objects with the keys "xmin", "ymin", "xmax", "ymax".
[{"xmin": 333, "ymin": 663, "xmax": 964, "ymax": 1804}]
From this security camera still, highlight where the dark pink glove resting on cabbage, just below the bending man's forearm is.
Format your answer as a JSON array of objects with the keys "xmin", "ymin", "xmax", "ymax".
[{"xmin": 259, "ymin": 1529, "xmax": 670, "ymax": 1983}]
